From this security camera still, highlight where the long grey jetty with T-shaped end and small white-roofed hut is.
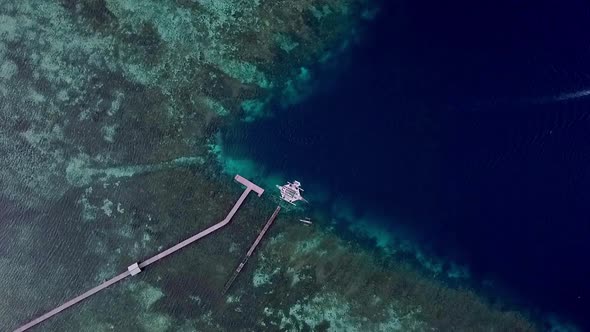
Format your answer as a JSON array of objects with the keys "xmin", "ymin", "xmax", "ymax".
[{"xmin": 14, "ymin": 175, "xmax": 264, "ymax": 332}]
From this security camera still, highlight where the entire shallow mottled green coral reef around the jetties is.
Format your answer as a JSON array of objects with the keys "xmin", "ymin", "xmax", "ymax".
[{"xmin": 0, "ymin": 0, "xmax": 544, "ymax": 331}]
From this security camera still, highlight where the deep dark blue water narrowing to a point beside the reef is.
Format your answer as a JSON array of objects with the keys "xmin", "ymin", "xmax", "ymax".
[{"xmin": 225, "ymin": 1, "xmax": 590, "ymax": 328}]
